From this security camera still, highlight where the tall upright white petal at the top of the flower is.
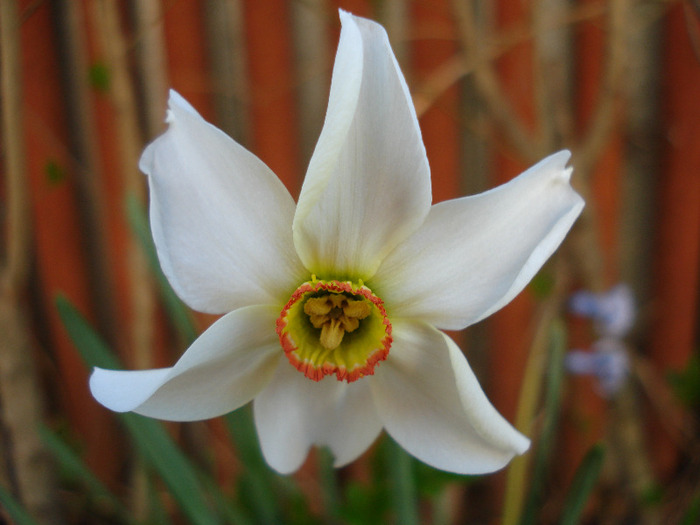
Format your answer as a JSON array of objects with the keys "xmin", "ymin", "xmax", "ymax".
[{"xmin": 294, "ymin": 12, "xmax": 431, "ymax": 279}]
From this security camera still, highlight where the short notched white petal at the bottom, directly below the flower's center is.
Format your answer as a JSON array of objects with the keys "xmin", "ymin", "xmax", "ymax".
[{"xmin": 253, "ymin": 358, "xmax": 382, "ymax": 474}]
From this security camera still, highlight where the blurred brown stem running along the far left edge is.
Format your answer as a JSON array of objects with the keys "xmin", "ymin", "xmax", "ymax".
[{"xmin": 0, "ymin": 2, "xmax": 60, "ymax": 523}]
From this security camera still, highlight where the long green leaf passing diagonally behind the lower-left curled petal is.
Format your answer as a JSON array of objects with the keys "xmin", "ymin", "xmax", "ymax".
[{"xmin": 56, "ymin": 296, "xmax": 220, "ymax": 525}]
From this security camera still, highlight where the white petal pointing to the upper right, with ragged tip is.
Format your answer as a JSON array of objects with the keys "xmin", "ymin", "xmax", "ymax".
[{"xmin": 368, "ymin": 151, "xmax": 583, "ymax": 329}]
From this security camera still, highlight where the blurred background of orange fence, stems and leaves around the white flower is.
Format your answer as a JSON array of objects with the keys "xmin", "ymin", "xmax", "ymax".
[{"xmin": 0, "ymin": 0, "xmax": 700, "ymax": 524}]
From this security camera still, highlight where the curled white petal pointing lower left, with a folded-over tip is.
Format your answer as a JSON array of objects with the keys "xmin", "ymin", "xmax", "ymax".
[{"xmin": 90, "ymin": 306, "xmax": 283, "ymax": 421}]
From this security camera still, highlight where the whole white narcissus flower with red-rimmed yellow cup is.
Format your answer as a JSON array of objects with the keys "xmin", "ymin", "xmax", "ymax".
[{"xmin": 90, "ymin": 12, "xmax": 583, "ymax": 473}]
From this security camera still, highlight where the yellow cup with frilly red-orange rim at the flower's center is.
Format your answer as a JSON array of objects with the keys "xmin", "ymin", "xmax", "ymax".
[{"xmin": 277, "ymin": 276, "xmax": 392, "ymax": 383}]
